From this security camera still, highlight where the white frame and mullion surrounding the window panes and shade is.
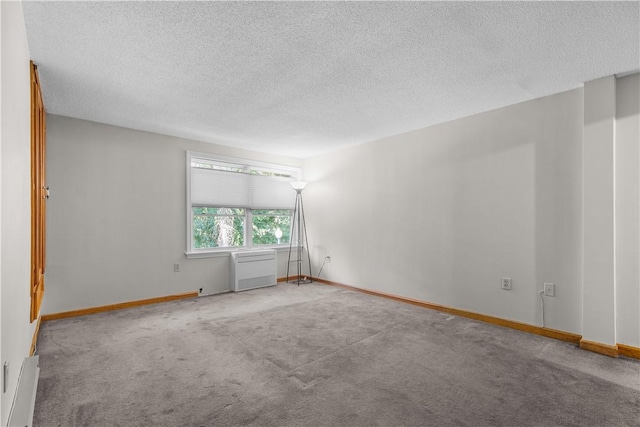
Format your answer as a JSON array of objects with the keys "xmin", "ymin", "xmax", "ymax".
[{"xmin": 185, "ymin": 151, "xmax": 302, "ymax": 258}]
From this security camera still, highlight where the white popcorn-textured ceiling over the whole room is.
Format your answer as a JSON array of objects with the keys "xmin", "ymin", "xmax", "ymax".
[{"xmin": 23, "ymin": 1, "xmax": 640, "ymax": 157}]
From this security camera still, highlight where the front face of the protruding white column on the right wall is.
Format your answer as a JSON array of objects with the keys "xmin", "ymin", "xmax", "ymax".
[{"xmin": 582, "ymin": 76, "xmax": 616, "ymax": 346}]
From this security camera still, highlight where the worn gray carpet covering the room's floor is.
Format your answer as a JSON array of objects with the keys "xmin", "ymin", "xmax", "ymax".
[{"xmin": 34, "ymin": 284, "xmax": 640, "ymax": 427}]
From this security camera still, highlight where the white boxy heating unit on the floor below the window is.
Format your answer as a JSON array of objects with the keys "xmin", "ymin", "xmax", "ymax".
[{"xmin": 230, "ymin": 250, "xmax": 278, "ymax": 292}]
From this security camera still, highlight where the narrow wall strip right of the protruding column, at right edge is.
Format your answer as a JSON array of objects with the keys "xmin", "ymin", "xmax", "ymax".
[{"xmin": 615, "ymin": 74, "xmax": 640, "ymax": 347}]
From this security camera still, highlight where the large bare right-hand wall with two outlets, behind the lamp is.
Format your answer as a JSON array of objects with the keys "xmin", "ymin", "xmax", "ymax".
[{"xmin": 304, "ymin": 89, "xmax": 583, "ymax": 333}]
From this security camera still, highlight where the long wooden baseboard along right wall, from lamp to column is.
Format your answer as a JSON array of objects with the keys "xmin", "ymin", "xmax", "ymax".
[{"xmin": 313, "ymin": 278, "xmax": 582, "ymax": 344}]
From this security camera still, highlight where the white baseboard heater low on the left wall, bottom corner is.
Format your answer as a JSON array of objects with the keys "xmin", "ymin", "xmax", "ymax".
[{"xmin": 8, "ymin": 356, "xmax": 40, "ymax": 427}]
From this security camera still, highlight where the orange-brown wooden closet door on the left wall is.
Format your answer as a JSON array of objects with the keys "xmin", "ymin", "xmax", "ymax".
[{"xmin": 30, "ymin": 62, "xmax": 49, "ymax": 322}]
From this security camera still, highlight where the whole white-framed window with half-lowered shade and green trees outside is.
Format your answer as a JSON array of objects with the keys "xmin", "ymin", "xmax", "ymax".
[{"xmin": 187, "ymin": 152, "xmax": 300, "ymax": 256}]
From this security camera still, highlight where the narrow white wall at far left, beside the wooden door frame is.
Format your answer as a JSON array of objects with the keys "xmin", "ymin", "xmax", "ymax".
[{"xmin": 0, "ymin": 1, "xmax": 35, "ymax": 425}]
